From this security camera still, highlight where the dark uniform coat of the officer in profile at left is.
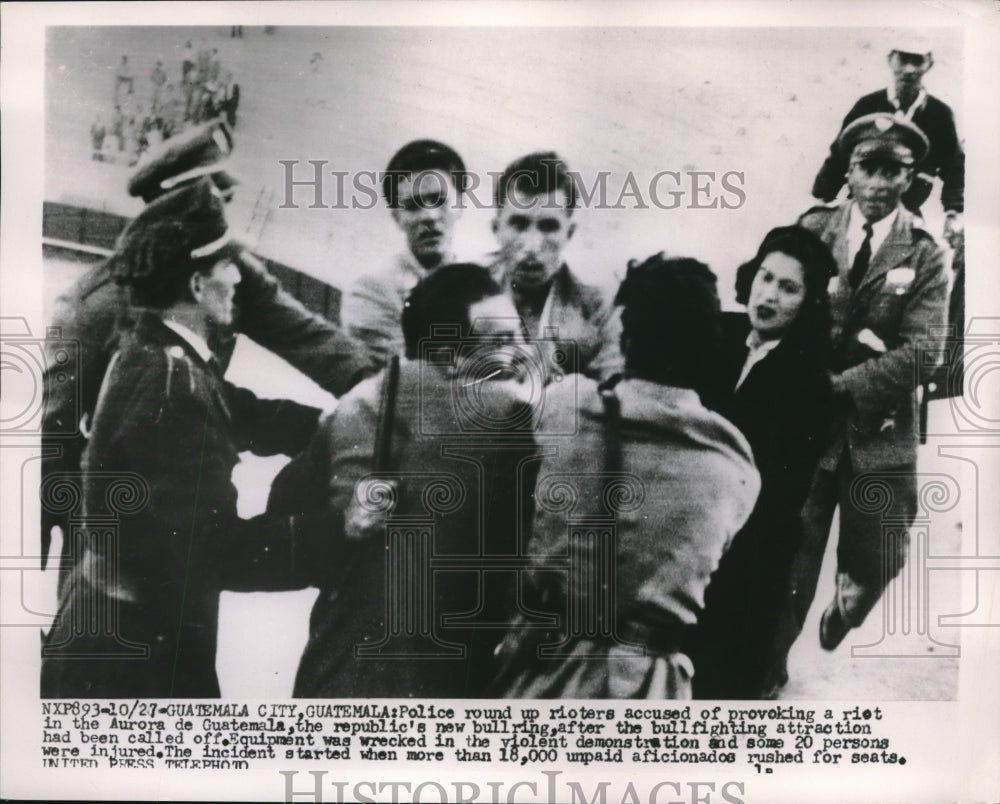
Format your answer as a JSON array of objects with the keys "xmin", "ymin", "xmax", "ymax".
[{"xmin": 42, "ymin": 312, "xmax": 332, "ymax": 698}]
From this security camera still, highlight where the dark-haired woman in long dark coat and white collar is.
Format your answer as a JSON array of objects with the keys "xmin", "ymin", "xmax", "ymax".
[{"xmin": 691, "ymin": 226, "xmax": 837, "ymax": 699}]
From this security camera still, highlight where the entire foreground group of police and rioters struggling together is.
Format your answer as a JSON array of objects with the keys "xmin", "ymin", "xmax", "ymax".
[{"xmin": 41, "ymin": 33, "xmax": 964, "ymax": 699}]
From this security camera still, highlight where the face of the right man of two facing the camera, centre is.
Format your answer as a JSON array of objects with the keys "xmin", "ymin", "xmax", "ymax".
[{"xmin": 493, "ymin": 188, "xmax": 575, "ymax": 288}]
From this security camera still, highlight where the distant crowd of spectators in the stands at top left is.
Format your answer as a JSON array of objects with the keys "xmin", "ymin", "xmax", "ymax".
[{"xmin": 90, "ymin": 42, "xmax": 242, "ymax": 165}]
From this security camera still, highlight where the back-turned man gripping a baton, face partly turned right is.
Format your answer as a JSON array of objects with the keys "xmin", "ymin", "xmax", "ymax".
[{"xmin": 286, "ymin": 264, "xmax": 534, "ymax": 698}]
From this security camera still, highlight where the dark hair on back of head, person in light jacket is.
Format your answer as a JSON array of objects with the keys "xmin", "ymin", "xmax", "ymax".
[{"xmin": 615, "ymin": 253, "xmax": 721, "ymax": 394}]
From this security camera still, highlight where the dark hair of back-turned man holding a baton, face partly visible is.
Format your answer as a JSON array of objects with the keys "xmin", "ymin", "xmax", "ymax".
[{"xmin": 403, "ymin": 262, "xmax": 503, "ymax": 360}]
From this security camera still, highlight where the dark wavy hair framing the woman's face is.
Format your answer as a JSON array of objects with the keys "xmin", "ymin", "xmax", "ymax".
[{"xmin": 736, "ymin": 225, "xmax": 837, "ymax": 357}]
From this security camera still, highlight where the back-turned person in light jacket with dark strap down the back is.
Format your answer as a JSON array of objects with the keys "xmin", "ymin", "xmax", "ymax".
[{"xmin": 496, "ymin": 255, "xmax": 760, "ymax": 698}]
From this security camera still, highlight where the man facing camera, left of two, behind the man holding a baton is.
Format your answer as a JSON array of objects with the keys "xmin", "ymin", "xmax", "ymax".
[{"xmin": 340, "ymin": 140, "xmax": 466, "ymax": 366}]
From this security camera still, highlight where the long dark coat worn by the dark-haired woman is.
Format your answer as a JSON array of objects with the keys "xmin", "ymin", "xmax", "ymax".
[{"xmin": 690, "ymin": 314, "xmax": 832, "ymax": 699}]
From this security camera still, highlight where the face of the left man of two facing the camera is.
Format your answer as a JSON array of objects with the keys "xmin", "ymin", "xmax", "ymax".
[{"xmin": 392, "ymin": 170, "xmax": 461, "ymax": 268}]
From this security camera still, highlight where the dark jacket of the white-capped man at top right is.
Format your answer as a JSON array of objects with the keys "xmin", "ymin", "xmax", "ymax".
[{"xmin": 812, "ymin": 89, "xmax": 965, "ymax": 212}]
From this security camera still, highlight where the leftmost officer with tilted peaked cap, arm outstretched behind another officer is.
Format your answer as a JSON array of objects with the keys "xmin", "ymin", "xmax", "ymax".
[{"xmin": 41, "ymin": 121, "xmax": 374, "ymax": 584}]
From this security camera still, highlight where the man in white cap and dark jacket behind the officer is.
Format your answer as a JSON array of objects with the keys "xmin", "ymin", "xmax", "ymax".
[{"xmin": 812, "ymin": 36, "xmax": 965, "ymax": 240}]
